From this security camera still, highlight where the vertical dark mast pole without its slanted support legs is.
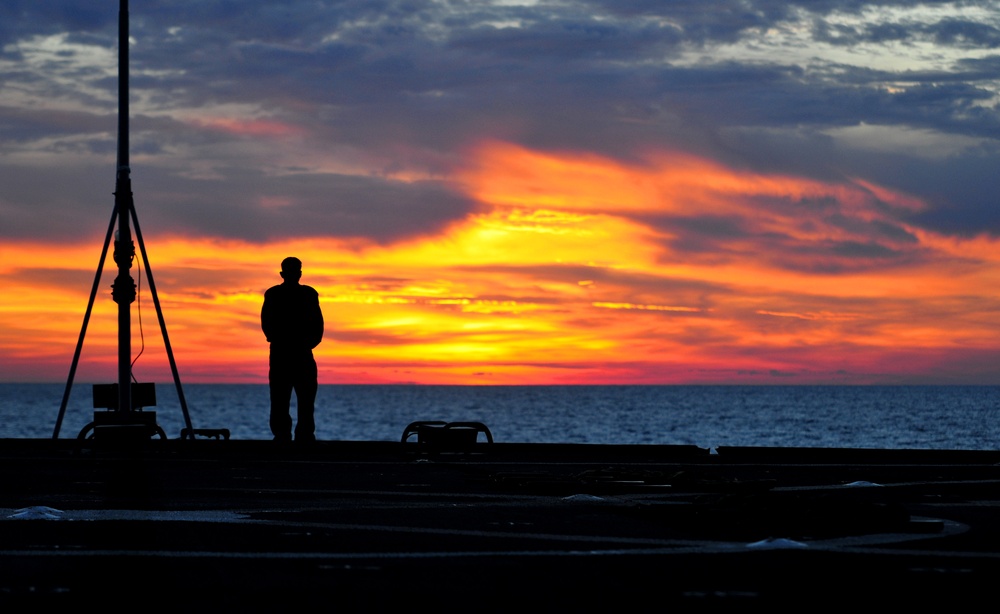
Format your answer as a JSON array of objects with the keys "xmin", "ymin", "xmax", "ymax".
[{"xmin": 111, "ymin": 0, "xmax": 136, "ymax": 412}]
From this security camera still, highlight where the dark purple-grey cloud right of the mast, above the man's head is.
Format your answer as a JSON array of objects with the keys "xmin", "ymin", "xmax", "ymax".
[{"xmin": 136, "ymin": 168, "xmax": 474, "ymax": 243}]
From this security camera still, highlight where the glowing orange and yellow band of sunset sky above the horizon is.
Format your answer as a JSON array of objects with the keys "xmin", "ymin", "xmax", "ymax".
[{"xmin": 0, "ymin": 141, "xmax": 1000, "ymax": 385}]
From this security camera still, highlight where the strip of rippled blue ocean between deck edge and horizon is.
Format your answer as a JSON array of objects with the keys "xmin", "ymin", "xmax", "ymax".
[{"xmin": 0, "ymin": 382, "xmax": 1000, "ymax": 450}]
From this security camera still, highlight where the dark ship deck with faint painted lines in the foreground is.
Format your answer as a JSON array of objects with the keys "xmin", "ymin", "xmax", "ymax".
[{"xmin": 0, "ymin": 440, "xmax": 1000, "ymax": 612}]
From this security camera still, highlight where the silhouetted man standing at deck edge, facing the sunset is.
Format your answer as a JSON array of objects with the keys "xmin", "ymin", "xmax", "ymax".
[{"xmin": 260, "ymin": 257, "xmax": 323, "ymax": 441}]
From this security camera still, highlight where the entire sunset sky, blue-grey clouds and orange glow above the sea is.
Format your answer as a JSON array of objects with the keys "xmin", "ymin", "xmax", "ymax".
[{"xmin": 0, "ymin": 0, "xmax": 1000, "ymax": 385}]
